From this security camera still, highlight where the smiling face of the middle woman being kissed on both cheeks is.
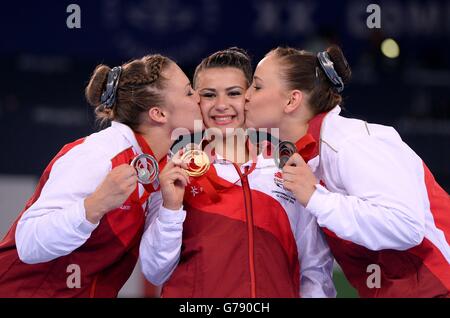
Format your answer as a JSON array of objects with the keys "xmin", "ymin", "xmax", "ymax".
[{"xmin": 196, "ymin": 67, "xmax": 247, "ymax": 134}]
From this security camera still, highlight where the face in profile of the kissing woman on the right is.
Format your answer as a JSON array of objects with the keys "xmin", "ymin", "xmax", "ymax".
[{"xmin": 245, "ymin": 55, "xmax": 289, "ymax": 128}]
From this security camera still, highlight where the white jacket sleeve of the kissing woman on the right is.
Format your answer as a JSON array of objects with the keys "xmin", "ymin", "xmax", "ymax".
[{"xmin": 307, "ymin": 136, "xmax": 425, "ymax": 250}]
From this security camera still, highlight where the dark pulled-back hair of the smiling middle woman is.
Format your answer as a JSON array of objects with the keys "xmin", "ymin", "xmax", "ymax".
[{"xmin": 193, "ymin": 47, "xmax": 253, "ymax": 88}]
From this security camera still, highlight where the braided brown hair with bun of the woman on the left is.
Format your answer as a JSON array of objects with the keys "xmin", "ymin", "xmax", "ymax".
[{"xmin": 85, "ymin": 54, "xmax": 173, "ymax": 131}]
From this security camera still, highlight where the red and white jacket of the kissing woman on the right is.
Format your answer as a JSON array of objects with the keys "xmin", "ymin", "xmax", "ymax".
[{"xmin": 306, "ymin": 106, "xmax": 450, "ymax": 297}]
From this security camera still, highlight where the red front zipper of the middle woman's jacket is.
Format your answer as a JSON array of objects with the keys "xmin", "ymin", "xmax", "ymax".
[{"xmin": 235, "ymin": 165, "xmax": 256, "ymax": 298}]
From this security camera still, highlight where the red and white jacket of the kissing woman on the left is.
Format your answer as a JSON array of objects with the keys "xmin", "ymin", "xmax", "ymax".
[{"xmin": 0, "ymin": 122, "xmax": 156, "ymax": 297}]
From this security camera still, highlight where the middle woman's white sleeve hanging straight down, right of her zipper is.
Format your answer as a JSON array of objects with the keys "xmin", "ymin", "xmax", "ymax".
[{"xmin": 296, "ymin": 207, "xmax": 336, "ymax": 298}]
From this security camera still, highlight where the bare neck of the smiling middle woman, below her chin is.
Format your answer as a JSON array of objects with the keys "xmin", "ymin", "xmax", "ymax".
[{"xmin": 215, "ymin": 129, "xmax": 250, "ymax": 164}]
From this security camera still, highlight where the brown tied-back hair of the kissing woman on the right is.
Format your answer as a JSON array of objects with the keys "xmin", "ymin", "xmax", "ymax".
[{"xmin": 266, "ymin": 45, "xmax": 352, "ymax": 114}]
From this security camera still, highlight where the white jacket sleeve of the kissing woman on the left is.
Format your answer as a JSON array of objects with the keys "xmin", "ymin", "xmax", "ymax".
[{"xmin": 15, "ymin": 144, "xmax": 111, "ymax": 264}]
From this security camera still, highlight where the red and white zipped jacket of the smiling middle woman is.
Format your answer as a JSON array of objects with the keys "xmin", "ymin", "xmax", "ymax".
[{"xmin": 140, "ymin": 155, "xmax": 336, "ymax": 297}]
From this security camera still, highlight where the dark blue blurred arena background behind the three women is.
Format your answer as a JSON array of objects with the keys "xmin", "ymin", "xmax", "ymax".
[{"xmin": 0, "ymin": 0, "xmax": 450, "ymax": 296}]
